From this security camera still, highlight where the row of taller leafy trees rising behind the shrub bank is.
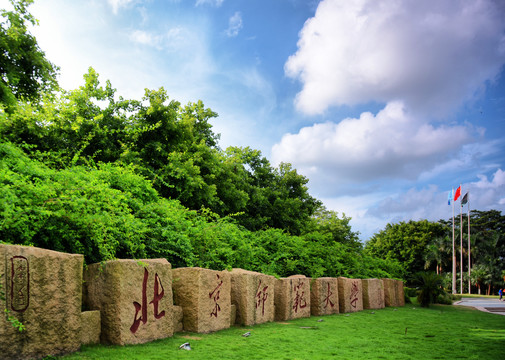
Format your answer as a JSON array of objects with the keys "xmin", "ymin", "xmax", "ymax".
[{"xmin": 0, "ymin": 68, "xmax": 321, "ymax": 235}]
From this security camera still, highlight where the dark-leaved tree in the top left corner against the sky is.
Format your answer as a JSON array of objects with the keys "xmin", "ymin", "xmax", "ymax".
[{"xmin": 0, "ymin": 0, "xmax": 58, "ymax": 112}]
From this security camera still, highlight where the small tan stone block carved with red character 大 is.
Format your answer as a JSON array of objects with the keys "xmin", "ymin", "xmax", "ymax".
[{"xmin": 310, "ymin": 277, "xmax": 339, "ymax": 316}]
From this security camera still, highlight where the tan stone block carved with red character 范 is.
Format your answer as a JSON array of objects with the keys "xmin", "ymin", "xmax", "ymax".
[{"xmin": 274, "ymin": 275, "xmax": 310, "ymax": 321}]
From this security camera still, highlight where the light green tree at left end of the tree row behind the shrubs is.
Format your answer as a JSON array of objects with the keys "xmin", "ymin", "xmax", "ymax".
[{"xmin": 0, "ymin": 68, "xmax": 139, "ymax": 168}]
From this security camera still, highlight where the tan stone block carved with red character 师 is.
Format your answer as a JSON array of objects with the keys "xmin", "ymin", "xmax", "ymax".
[{"xmin": 230, "ymin": 269, "xmax": 276, "ymax": 326}]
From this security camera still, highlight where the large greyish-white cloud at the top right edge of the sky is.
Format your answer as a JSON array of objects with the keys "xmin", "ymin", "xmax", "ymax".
[{"xmin": 285, "ymin": 0, "xmax": 505, "ymax": 115}]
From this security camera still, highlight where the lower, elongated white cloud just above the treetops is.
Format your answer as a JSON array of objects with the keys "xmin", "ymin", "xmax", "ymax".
[{"xmin": 272, "ymin": 102, "xmax": 473, "ymax": 182}]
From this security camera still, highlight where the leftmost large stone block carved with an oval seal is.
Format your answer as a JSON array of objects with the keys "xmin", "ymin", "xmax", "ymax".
[{"xmin": 0, "ymin": 244, "xmax": 83, "ymax": 359}]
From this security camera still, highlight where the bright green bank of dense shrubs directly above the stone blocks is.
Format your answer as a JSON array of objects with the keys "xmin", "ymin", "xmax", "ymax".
[{"xmin": 0, "ymin": 143, "xmax": 401, "ymax": 277}]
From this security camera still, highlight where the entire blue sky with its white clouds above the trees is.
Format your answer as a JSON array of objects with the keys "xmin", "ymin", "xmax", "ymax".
[{"xmin": 4, "ymin": 0, "xmax": 505, "ymax": 240}]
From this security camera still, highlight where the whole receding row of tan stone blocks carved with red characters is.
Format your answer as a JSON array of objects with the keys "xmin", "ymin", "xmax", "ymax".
[{"xmin": 0, "ymin": 244, "xmax": 405, "ymax": 360}]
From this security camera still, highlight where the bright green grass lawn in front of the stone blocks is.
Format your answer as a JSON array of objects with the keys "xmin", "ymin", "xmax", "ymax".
[{"xmin": 57, "ymin": 304, "xmax": 505, "ymax": 360}]
